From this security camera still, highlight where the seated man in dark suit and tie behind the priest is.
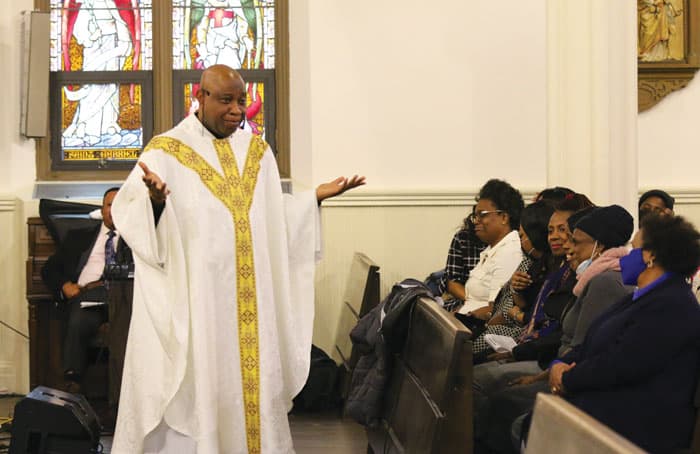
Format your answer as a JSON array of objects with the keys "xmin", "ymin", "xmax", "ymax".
[{"xmin": 42, "ymin": 187, "xmax": 131, "ymax": 393}]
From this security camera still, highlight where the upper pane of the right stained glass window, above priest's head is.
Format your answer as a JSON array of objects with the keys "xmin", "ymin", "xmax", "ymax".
[{"xmin": 173, "ymin": 0, "xmax": 275, "ymax": 69}]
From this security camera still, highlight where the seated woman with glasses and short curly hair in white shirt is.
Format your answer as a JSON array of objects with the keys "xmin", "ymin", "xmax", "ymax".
[{"xmin": 454, "ymin": 179, "xmax": 524, "ymax": 330}]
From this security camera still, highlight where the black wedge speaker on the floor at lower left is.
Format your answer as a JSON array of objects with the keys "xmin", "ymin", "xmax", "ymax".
[{"xmin": 9, "ymin": 386, "xmax": 100, "ymax": 454}]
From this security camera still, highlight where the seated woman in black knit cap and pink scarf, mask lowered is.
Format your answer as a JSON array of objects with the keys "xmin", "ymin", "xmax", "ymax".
[{"xmin": 474, "ymin": 205, "xmax": 634, "ymax": 452}]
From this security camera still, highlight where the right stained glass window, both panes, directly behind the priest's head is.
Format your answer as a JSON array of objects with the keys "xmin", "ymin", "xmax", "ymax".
[{"xmin": 172, "ymin": 0, "xmax": 275, "ymax": 149}]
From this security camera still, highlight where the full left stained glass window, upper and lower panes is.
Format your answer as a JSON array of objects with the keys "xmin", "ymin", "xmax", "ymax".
[{"xmin": 50, "ymin": 0, "xmax": 153, "ymax": 169}]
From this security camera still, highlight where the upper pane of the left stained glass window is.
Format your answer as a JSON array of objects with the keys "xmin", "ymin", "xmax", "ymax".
[{"xmin": 51, "ymin": 0, "xmax": 153, "ymax": 71}]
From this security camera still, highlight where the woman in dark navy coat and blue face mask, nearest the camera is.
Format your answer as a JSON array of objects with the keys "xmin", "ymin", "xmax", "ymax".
[{"xmin": 549, "ymin": 216, "xmax": 700, "ymax": 452}]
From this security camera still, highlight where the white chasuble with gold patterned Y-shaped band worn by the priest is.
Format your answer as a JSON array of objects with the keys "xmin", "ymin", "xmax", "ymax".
[{"xmin": 112, "ymin": 115, "xmax": 320, "ymax": 454}]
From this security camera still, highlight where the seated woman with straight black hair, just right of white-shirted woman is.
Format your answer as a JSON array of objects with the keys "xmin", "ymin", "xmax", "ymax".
[{"xmin": 473, "ymin": 201, "xmax": 563, "ymax": 362}]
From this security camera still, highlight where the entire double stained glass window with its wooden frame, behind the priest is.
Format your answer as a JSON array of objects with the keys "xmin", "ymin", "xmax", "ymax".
[{"xmin": 41, "ymin": 0, "xmax": 289, "ymax": 178}]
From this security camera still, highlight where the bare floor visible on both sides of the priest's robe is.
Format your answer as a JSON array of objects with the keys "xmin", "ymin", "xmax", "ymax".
[{"xmin": 0, "ymin": 397, "xmax": 367, "ymax": 454}]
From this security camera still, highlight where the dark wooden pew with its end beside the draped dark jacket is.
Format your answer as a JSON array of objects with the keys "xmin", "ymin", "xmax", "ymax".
[{"xmin": 367, "ymin": 298, "xmax": 473, "ymax": 454}]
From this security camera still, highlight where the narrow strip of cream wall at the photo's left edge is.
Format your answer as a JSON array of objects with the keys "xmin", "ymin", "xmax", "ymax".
[{"xmin": 0, "ymin": 0, "xmax": 36, "ymax": 393}]
